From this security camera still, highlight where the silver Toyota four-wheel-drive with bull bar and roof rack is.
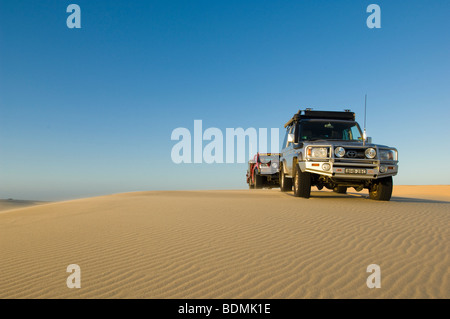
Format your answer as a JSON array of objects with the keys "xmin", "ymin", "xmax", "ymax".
[{"xmin": 279, "ymin": 109, "xmax": 398, "ymax": 201}]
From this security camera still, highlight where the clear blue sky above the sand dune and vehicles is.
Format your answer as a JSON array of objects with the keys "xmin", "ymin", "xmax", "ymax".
[{"xmin": 0, "ymin": 0, "xmax": 450, "ymax": 200}]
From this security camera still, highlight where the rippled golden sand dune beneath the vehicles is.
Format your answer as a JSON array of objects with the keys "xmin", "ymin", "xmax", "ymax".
[{"xmin": 0, "ymin": 186, "xmax": 450, "ymax": 298}]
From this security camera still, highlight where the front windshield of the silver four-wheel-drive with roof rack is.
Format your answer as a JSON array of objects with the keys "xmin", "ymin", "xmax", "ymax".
[{"xmin": 299, "ymin": 120, "xmax": 362, "ymax": 141}]
